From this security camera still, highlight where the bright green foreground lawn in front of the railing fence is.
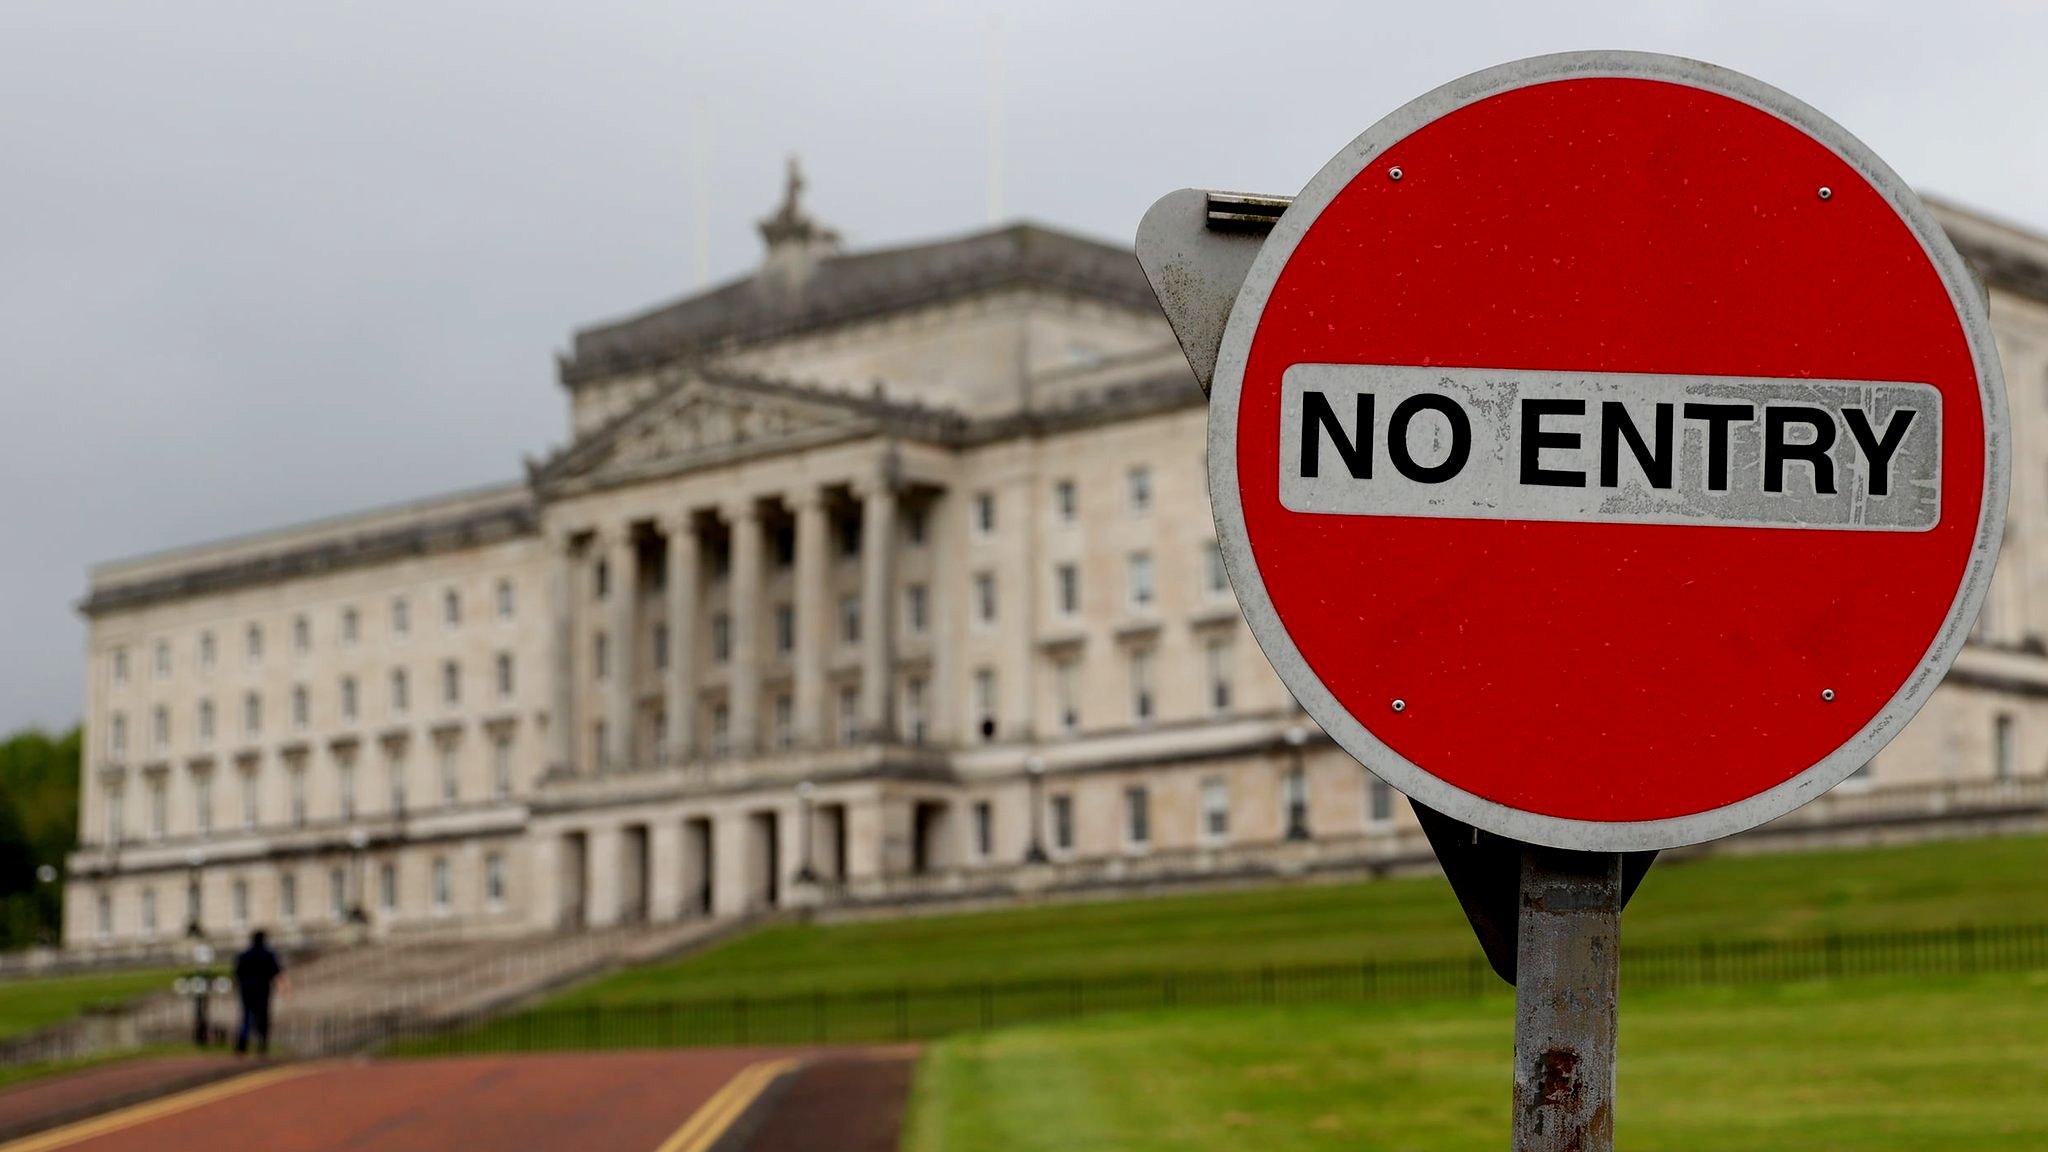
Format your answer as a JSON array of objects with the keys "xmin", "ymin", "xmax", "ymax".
[{"xmin": 905, "ymin": 974, "xmax": 2048, "ymax": 1152}]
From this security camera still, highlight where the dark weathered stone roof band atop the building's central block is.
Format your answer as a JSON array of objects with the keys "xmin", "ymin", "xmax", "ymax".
[{"xmin": 561, "ymin": 223, "xmax": 1159, "ymax": 387}]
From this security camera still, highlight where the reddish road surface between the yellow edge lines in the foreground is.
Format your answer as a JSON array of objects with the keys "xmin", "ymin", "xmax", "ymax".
[{"xmin": 0, "ymin": 1047, "xmax": 823, "ymax": 1152}]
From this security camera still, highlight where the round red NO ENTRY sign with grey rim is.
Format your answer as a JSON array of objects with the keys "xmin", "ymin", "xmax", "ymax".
[{"xmin": 1208, "ymin": 53, "xmax": 2007, "ymax": 851}]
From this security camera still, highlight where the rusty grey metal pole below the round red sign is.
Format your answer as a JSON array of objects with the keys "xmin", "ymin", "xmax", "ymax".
[{"xmin": 1513, "ymin": 845, "xmax": 1622, "ymax": 1152}]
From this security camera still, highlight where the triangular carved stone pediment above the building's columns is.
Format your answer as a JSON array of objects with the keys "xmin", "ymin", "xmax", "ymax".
[{"xmin": 532, "ymin": 371, "xmax": 963, "ymax": 496}]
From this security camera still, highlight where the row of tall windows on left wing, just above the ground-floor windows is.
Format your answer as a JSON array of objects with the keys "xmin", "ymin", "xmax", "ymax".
[{"xmin": 104, "ymin": 730, "xmax": 514, "ymax": 845}]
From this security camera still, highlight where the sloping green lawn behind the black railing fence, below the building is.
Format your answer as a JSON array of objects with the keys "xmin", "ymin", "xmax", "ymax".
[{"xmin": 551, "ymin": 836, "xmax": 2048, "ymax": 1006}]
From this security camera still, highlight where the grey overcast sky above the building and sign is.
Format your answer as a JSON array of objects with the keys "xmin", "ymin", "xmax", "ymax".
[{"xmin": 0, "ymin": 0, "xmax": 2048, "ymax": 732}]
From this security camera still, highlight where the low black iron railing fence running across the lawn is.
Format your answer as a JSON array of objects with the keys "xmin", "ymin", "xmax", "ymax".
[{"xmin": 376, "ymin": 924, "xmax": 2048, "ymax": 1054}]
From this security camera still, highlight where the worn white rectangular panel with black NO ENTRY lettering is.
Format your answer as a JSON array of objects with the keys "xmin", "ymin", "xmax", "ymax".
[{"xmin": 1278, "ymin": 363, "xmax": 1942, "ymax": 531}]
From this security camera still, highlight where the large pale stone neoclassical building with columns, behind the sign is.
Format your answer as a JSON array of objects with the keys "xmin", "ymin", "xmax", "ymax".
[{"xmin": 66, "ymin": 168, "xmax": 2048, "ymax": 949}]
